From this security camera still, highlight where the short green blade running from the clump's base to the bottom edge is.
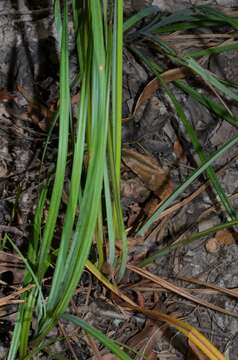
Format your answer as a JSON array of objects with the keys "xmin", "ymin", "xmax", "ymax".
[{"xmin": 62, "ymin": 314, "xmax": 131, "ymax": 360}]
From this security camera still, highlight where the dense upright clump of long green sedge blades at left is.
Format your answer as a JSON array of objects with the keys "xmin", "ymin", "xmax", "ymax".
[{"xmin": 8, "ymin": 0, "xmax": 128, "ymax": 359}]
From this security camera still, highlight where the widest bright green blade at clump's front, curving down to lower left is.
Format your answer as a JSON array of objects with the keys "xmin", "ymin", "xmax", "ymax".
[{"xmin": 30, "ymin": 0, "xmax": 111, "ymax": 344}]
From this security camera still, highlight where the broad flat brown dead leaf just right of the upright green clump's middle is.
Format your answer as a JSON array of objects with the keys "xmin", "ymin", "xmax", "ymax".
[{"xmin": 122, "ymin": 148, "xmax": 169, "ymax": 197}]
